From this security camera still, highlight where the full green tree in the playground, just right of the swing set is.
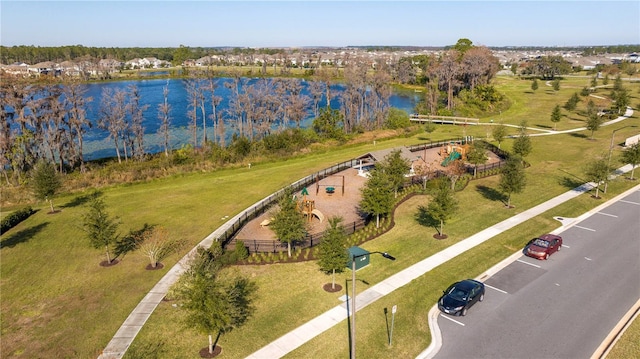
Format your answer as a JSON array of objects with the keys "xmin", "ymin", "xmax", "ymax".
[{"xmin": 360, "ymin": 168, "xmax": 394, "ymax": 228}]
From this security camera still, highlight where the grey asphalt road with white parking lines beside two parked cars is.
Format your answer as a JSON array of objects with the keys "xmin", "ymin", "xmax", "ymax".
[{"xmin": 435, "ymin": 191, "xmax": 640, "ymax": 359}]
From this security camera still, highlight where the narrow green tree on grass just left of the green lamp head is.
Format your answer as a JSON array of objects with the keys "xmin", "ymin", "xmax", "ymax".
[{"xmin": 318, "ymin": 217, "xmax": 349, "ymax": 289}]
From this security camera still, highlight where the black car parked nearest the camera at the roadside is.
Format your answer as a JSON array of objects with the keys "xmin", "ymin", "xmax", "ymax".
[{"xmin": 438, "ymin": 279, "xmax": 484, "ymax": 316}]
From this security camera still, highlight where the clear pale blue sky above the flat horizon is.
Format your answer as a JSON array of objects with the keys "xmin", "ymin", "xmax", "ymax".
[{"xmin": 0, "ymin": 0, "xmax": 640, "ymax": 48}]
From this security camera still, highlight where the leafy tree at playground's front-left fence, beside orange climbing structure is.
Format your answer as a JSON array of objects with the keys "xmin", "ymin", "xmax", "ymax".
[{"xmin": 269, "ymin": 189, "xmax": 307, "ymax": 257}]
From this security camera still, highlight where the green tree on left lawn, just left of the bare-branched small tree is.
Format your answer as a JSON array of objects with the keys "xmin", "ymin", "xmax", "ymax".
[{"xmin": 82, "ymin": 195, "xmax": 120, "ymax": 263}]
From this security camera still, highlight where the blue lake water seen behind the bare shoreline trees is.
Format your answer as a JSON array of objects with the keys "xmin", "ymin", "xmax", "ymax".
[{"xmin": 84, "ymin": 78, "xmax": 420, "ymax": 160}]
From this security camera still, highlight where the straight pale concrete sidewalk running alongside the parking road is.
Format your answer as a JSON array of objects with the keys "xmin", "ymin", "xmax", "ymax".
[{"xmin": 247, "ymin": 165, "xmax": 640, "ymax": 359}]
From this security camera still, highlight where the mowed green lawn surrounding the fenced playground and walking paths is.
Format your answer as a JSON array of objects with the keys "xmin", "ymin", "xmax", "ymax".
[{"xmin": 0, "ymin": 74, "xmax": 639, "ymax": 358}]
